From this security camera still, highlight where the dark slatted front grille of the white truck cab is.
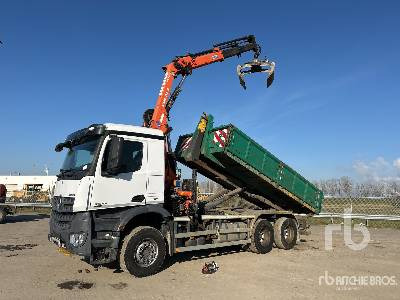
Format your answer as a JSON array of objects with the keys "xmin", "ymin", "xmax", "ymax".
[{"xmin": 51, "ymin": 196, "xmax": 75, "ymax": 230}]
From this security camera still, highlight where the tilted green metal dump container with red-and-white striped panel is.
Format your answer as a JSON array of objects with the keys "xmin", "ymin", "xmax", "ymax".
[{"xmin": 175, "ymin": 115, "xmax": 323, "ymax": 214}]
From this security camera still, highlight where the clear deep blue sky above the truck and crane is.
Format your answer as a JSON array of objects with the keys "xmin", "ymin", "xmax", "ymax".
[{"xmin": 0, "ymin": 0, "xmax": 400, "ymax": 180}]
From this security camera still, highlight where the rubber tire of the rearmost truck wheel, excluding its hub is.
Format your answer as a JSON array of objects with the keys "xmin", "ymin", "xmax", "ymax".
[{"xmin": 274, "ymin": 217, "xmax": 297, "ymax": 250}]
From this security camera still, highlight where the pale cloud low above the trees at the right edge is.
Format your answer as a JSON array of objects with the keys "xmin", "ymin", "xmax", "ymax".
[{"xmin": 353, "ymin": 156, "xmax": 400, "ymax": 181}]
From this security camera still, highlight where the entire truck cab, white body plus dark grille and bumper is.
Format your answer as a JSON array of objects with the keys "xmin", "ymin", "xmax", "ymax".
[{"xmin": 49, "ymin": 123, "xmax": 169, "ymax": 270}]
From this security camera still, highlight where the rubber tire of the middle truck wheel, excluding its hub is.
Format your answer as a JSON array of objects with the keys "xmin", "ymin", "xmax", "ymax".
[{"xmin": 249, "ymin": 219, "xmax": 274, "ymax": 254}]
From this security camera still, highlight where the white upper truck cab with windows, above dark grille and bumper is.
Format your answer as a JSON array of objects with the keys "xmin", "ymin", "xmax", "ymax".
[{"xmin": 54, "ymin": 123, "xmax": 165, "ymax": 212}]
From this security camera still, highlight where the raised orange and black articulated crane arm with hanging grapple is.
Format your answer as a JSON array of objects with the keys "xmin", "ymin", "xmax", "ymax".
[{"xmin": 143, "ymin": 35, "xmax": 275, "ymax": 135}]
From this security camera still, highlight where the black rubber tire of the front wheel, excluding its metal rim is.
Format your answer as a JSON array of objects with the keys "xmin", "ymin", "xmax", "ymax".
[{"xmin": 119, "ymin": 226, "xmax": 166, "ymax": 277}]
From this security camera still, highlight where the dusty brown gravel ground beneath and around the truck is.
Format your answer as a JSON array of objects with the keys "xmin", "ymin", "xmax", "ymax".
[{"xmin": 0, "ymin": 215, "xmax": 400, "ymax": 299}]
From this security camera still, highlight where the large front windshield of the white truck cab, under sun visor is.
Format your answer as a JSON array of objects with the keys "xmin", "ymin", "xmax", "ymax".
[{"xmin": 61, "ymin": 139, "xmax": 99, "ymax": 171}]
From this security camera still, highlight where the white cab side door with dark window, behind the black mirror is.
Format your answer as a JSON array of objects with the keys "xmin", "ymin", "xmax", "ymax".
[{"xmin": 89, "ymin": 136, "xmax": 148, "ymax": 209}]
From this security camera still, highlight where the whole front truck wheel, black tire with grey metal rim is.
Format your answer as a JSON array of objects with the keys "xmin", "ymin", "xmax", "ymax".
[{"xmin": 119, "ymin": 226, "xmax": 166, "ymax": 277}]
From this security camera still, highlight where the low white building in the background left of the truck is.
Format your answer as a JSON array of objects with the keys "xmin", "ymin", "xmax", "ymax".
[{"xmin": 0, "ymin": 175, "xmax": 57, "ymax": 201}]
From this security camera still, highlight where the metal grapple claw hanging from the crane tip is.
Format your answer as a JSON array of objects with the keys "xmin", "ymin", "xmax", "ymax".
[{"xmin": 236, "ymin": 58, "xmax": 275, "ymax": 89}]
